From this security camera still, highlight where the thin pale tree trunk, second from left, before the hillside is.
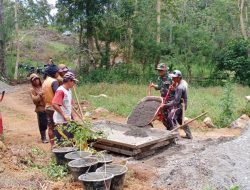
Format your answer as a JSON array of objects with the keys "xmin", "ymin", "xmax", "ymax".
[{"xmin": 14, "ymin": 0, "xmax": 20, "ymax": 81}]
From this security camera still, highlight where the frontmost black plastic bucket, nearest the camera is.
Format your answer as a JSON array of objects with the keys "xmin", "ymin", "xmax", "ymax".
[{"xmin": 78, "ymin": 172, "xmax": 114, "ymax": 190}]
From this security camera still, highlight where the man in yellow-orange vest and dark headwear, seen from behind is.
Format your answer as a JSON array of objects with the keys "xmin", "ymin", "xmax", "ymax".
[{"xmin": 42, "ymin": 64, "xmax": 59, "ymax": 147}]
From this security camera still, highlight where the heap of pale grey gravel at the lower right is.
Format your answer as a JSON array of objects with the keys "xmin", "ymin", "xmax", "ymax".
[{"xmin": 153, "ymin": 122, "xmax": 250, "ymax": 190}]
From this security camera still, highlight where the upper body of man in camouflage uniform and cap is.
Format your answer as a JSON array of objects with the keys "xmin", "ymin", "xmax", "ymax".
[{"xmin": 149, "ymin": 63, "xmax": 172, "ymax": 97}]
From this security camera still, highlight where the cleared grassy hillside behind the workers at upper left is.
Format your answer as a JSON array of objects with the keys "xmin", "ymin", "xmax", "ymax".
[{"xmin": 7, "ymin": 28, "xmax": 77, "ymax": 78}]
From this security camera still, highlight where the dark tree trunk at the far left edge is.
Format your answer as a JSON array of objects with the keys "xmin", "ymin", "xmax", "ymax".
[{"xmin": 0, "ymin": 0, "xmax": 6, "ymax": 77}]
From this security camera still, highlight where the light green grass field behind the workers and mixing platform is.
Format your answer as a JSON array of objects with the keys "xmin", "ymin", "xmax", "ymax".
[{"xmin": 78, "ymin": 83, "xmax": 250, "ymax": 127}]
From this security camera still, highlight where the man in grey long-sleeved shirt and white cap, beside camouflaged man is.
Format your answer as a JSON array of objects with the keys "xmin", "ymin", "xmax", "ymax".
[{"xmin": 162, "ymin": 70, "xmax": 193, "ymax": 139}]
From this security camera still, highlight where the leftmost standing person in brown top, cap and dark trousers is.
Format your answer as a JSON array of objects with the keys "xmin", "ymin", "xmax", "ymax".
[{"xmin": 30, "ymin": 73, "xmax": 48, "ymax": 143}]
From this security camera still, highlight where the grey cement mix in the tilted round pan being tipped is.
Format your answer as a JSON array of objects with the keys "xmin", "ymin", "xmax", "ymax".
[{"xmin": 127, "ymin": 99, "xmax": 161, "ymax": 127}]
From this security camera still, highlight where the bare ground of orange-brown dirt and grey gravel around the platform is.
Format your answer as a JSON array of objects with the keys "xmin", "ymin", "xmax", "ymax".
[{"xmin": 0, "ymin": 85, "xmax": 250, "ymax": 190}]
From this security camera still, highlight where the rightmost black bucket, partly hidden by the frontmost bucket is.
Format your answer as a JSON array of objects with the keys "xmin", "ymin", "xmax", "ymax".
[{"xmin": 96, "ymin": 164, "xmax": 128, "ymax": 190}]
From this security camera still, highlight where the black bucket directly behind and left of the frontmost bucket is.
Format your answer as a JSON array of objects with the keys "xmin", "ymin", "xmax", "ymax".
[{"xmin": 68, "ymin": 158, "xmax": 98, "ymax": 181}]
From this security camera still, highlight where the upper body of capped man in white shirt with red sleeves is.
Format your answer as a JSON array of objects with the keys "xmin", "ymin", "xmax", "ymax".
[{"xmin": 52, "ymin": 72, "xmax": 78, "ymax": 139}]
